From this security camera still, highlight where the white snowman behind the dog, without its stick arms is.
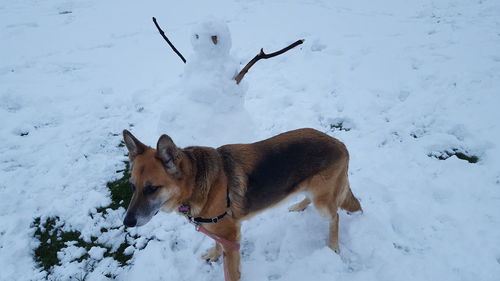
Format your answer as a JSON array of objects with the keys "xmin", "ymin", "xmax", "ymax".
[{"xmin": 158, "ymin": 19, "xmax": 254, "ymax": 146}]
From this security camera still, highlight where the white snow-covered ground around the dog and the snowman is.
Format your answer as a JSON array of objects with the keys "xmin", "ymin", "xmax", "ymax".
[{"xmin": 0, "ymin": 0, "xmax": 500, "ymax": 281}]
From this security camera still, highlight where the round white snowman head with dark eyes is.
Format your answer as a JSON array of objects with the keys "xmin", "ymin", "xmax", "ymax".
[{"xmin": 191, "ymin": 19, "xmax": 231, "ymax": 58}]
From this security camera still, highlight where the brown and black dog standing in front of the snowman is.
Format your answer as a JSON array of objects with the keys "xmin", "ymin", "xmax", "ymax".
[{"xmin": 123, "ymin": 129, "xmax": 361, "ymax": 281}]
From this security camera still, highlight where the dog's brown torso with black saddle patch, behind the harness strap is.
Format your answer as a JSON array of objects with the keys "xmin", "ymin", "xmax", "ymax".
[{"xmin": 218, "ymin": 129, "xmax": 356, "ymax": 219}]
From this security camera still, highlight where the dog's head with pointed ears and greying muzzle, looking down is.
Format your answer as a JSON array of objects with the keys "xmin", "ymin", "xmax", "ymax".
[{"xmin": 123, "ymin": 130, "xmax": 189, "ymax": 227}]
